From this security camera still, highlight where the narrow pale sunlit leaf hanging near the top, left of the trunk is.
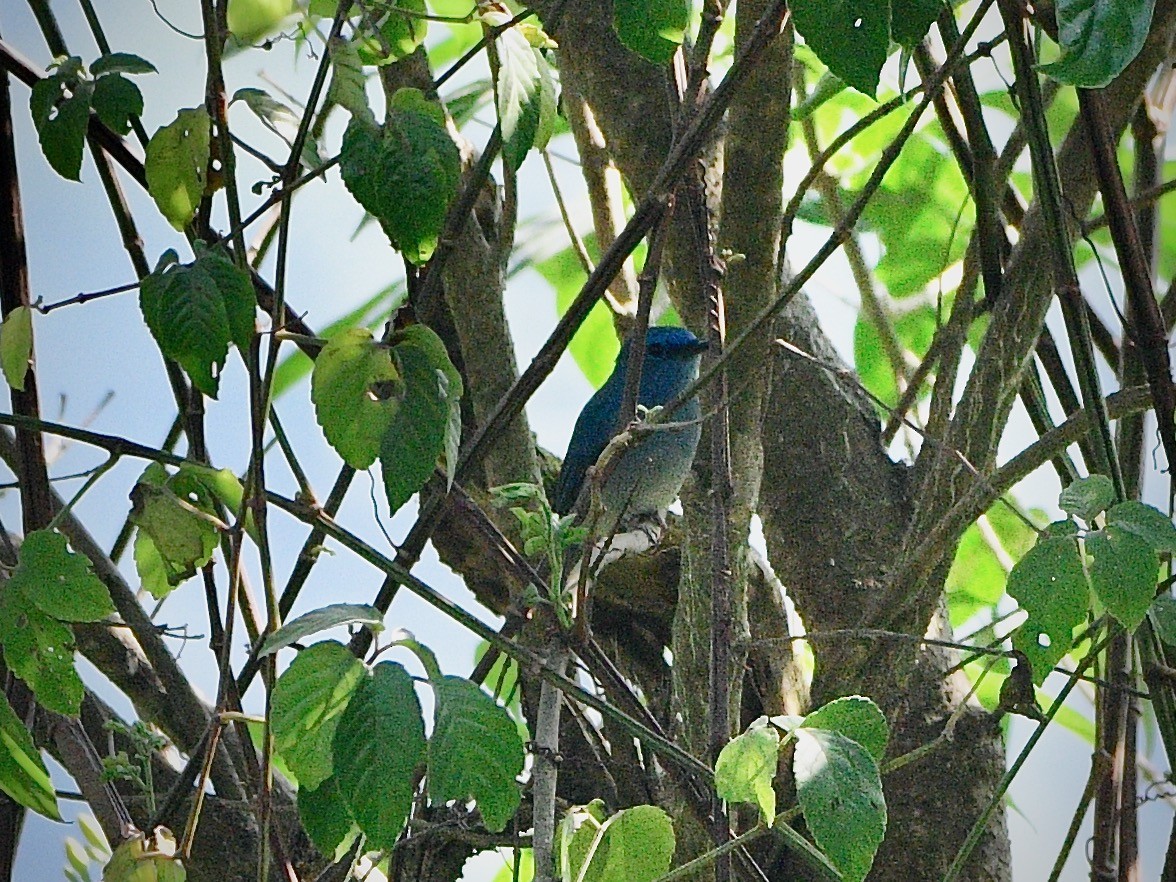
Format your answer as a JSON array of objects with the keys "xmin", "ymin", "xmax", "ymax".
[{"xmin": 481, "ymin": 8, "xmax": 547, "ymax": 171}]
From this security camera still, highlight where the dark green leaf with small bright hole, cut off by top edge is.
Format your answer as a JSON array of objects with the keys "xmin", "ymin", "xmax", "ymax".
[{"xmin": 790, "ymin": 0, "xmax": 890, "ymax": 98}]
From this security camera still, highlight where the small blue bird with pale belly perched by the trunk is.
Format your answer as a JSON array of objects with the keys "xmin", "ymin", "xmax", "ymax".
[{"xmin": 554, "ymin": 327, "xmax": 707, "ymax": 529}]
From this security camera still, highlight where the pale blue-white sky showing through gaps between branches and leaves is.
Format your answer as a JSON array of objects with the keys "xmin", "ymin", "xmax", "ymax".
[{"xmin": 0, "ymin": 0, "xmax": 1170, "ymax": 882}]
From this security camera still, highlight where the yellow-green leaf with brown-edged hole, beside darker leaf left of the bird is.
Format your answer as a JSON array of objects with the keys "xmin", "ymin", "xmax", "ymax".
[{"xmin": 310, "ymin": 328, "xmax": 406, "ymax": 469}]
